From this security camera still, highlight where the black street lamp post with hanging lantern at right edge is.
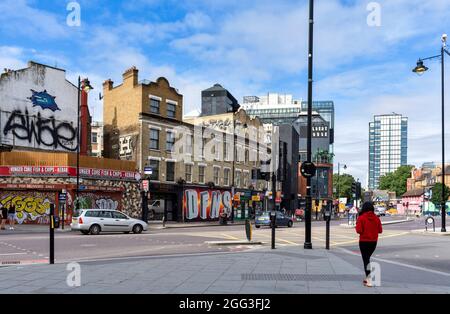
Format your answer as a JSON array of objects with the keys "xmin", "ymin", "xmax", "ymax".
[{"xmin": 413, "ymin": 34, "xmax": 450, "ymax": 232}]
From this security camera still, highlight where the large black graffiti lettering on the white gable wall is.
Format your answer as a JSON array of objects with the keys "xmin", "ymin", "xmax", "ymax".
[{"xmin": 3, "ymin": 109, "xmax": 77, "ymax": 151}]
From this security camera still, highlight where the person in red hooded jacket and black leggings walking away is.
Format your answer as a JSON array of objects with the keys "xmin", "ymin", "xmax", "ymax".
[{"xmin": 356, "ymin": 202, "xmax": 383, "ymax": 287}]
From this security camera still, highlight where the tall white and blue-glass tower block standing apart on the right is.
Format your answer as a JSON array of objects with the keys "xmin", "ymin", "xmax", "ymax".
[{"xmin": 369, "ymin": 113, "xmax": 408, "ymax": 190}]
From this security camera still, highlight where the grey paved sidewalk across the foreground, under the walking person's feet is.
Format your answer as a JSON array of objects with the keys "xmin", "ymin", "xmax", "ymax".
[{"xmin": 0, "ymin": 247, "xmax": 450, "ymax": 295}]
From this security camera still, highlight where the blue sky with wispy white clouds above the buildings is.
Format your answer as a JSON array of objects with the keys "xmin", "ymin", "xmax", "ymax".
[{"xmin": 0, "ymin": 0, "xmax": 450, "ymax": 184}]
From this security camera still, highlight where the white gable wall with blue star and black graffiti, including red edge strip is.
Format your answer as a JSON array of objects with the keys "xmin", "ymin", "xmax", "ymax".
[{"xmin": 0, "ymin": 61, "xmax": 90, "ymax": 155}]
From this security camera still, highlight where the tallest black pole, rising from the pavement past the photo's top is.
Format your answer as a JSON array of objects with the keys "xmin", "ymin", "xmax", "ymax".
[{"xmin": 304, "ymin": 0, "xmax": 314, "ymax": 250}]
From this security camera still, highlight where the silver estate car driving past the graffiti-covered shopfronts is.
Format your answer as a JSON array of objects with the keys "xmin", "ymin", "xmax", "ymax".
[{"xmin": 70, "ymin": 209, "xmax": 148, "ymax": 235}]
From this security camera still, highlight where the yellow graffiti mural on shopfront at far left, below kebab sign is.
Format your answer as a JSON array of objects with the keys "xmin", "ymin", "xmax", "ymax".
[{"xmin": 0, "ymin": 191, "xmax": 55, "ymax": 224}]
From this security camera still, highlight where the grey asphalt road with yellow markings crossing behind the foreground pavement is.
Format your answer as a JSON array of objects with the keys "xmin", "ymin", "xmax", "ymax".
[{"xmin": 0, "ymin": 219, "xmax": 440, "ymax": 269}]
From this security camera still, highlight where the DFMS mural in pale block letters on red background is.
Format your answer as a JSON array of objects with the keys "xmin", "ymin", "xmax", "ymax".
[{"xmin": 183, "ymin": 189, "xmax": 231, "ymax": 220}]
